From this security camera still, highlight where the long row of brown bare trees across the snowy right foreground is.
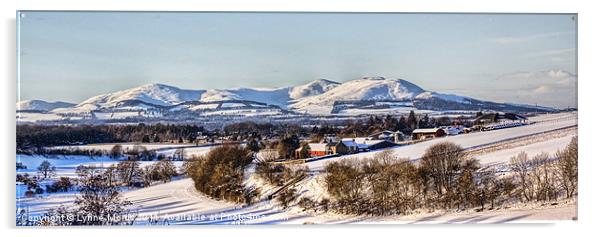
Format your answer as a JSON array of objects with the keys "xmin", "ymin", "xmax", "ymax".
[{"xmin": 326, "ymin": 137, "xmax": 577, "ymax": 215}]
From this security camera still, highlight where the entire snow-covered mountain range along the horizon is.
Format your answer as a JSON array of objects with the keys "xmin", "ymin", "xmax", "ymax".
[{"xmin": 17, "ymin": 77, "xmax": 553, "ymax": 124}]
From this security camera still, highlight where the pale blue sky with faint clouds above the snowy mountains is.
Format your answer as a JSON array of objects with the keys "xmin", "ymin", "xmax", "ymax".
[{"xmin": 18, "ymin": 12, "xmax": 576, "ymax": 107}]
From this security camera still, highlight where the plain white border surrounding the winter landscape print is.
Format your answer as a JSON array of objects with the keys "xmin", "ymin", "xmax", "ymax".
[{"xmin": 0, "ymin": 0, "xmax": 602, "ymax": 237}]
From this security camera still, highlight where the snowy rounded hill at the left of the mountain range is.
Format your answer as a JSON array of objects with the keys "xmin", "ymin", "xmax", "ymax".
[{"xmin": 77, "ymin": 84, "xmax": 205, "ymax": 107}]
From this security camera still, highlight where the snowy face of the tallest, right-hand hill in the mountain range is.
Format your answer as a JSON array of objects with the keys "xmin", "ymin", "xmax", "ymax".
[{"xmin": 291, "ymin": 77, "xmax": 424, "ymax": 112}]
